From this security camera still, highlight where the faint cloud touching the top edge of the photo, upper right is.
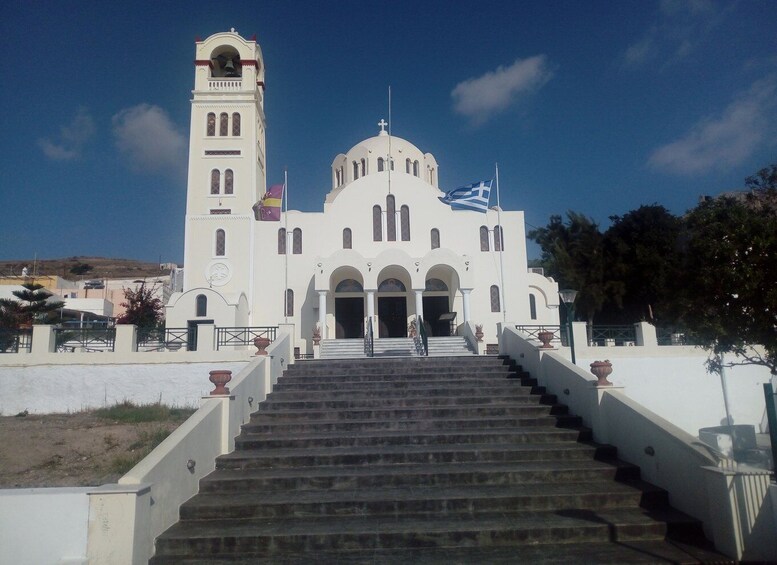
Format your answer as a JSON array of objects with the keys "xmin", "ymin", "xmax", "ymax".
[{"xmin": 623, "ymin": 0, "xmax": 731, "ymax": 66}]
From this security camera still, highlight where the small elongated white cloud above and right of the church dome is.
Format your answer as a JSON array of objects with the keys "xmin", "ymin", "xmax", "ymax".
[{"xmin": 451, "ymin": 55, "xmax": 553, "ymax": 125}]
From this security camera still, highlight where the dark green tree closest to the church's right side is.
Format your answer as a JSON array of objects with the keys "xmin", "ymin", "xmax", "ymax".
[{"xmin": 529, "ymin": 211, "xmax": 623, "ymax": 326}]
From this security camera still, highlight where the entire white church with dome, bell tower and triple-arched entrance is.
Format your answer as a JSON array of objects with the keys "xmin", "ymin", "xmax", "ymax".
[{"xmin": 166, "ymin": 30, "xmax": 559, "ymax": 353}]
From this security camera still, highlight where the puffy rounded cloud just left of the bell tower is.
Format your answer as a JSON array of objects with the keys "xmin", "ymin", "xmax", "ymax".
[{"xmin": 113, "ymin": 104, "xmax": 186, "ymax": 175}]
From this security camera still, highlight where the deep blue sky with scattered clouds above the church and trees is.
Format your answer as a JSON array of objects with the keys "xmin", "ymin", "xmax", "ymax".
[{"xmin": 0, "ymin": 0, "xmax": 777, "ymax": 262}]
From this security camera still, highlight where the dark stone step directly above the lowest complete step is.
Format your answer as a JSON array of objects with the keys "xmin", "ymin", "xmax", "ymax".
[{"xmin": 180, "ymin": 480, "xmax": 666, "ymax": 520}]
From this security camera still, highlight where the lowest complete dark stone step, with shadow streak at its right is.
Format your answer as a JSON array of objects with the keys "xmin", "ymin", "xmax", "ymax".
[{"xmin": 152, "ymin": 508, "xmax": 704, "ymax": 557}]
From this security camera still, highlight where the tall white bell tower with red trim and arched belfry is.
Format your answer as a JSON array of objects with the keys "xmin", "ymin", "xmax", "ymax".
[{"xmin": 184, "ymin": 28, "xmax": 266, "ymax": 304}]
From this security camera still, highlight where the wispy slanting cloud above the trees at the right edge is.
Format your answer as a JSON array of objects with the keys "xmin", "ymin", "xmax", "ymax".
[{"xmin": 648, "ymin": 77, "xmax": 777, "ymax": 174}]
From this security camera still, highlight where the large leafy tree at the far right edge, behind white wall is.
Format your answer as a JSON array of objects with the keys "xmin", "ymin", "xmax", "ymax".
[{"xmin": 677, "ymin": 181, "xmax": 777, "ymax": 374}]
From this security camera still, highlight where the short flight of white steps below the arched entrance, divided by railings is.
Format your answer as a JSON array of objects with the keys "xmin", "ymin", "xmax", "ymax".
[{"xmin": 321, "ymin": 336, "xmax": 474, "ymax": 359}]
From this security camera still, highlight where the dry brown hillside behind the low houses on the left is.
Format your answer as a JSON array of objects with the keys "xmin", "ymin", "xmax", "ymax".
[{"xmin": 0, "ymin": 256, "xmax": 169, "ymax": 281}]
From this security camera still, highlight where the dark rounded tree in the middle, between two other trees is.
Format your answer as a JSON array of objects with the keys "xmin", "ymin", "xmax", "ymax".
[{"xmin": 604, "ymin": 204, "xmax": 683, "ymax": 323}]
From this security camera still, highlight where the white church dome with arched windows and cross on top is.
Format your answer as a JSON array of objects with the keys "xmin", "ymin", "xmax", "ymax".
[{"xmin": 332, "ymin": 120, "xmax": 437, "ymax": 190}]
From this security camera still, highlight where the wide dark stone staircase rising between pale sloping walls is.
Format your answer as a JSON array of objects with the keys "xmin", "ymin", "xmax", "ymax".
[{"xmin": 151, "ymin": 356, "xmax": 728, "ymax": 565}]
